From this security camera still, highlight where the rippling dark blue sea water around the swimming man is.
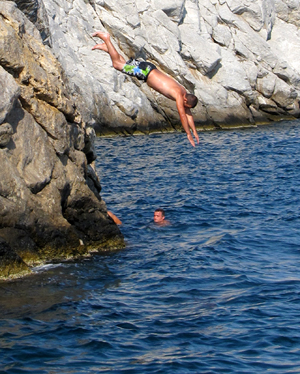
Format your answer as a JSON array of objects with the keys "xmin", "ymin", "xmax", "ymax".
[{"xmin": 0, "ymin": 121, "xmax": 300, "ymax": 374}]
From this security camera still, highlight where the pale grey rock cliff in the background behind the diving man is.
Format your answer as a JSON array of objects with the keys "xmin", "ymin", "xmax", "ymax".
[{"xmin": 9, "ymin": 0, "xmax": 300, "ymax": 133}]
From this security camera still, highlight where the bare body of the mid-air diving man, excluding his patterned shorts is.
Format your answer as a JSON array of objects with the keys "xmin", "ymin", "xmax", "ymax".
[{"xmin": 92, "ymin": 31, "xmax": 199, "ymax": 147}]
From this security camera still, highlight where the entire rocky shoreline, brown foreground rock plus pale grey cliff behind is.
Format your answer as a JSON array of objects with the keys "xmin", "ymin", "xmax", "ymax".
[{"xmin": 0, "ymin": 0, "xmax": 300, "ymax": 279}]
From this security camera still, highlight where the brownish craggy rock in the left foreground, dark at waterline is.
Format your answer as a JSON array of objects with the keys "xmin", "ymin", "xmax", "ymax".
[{"xmin": 0, "ymin": 1, "xmax": 123, "ymax": 278}]
